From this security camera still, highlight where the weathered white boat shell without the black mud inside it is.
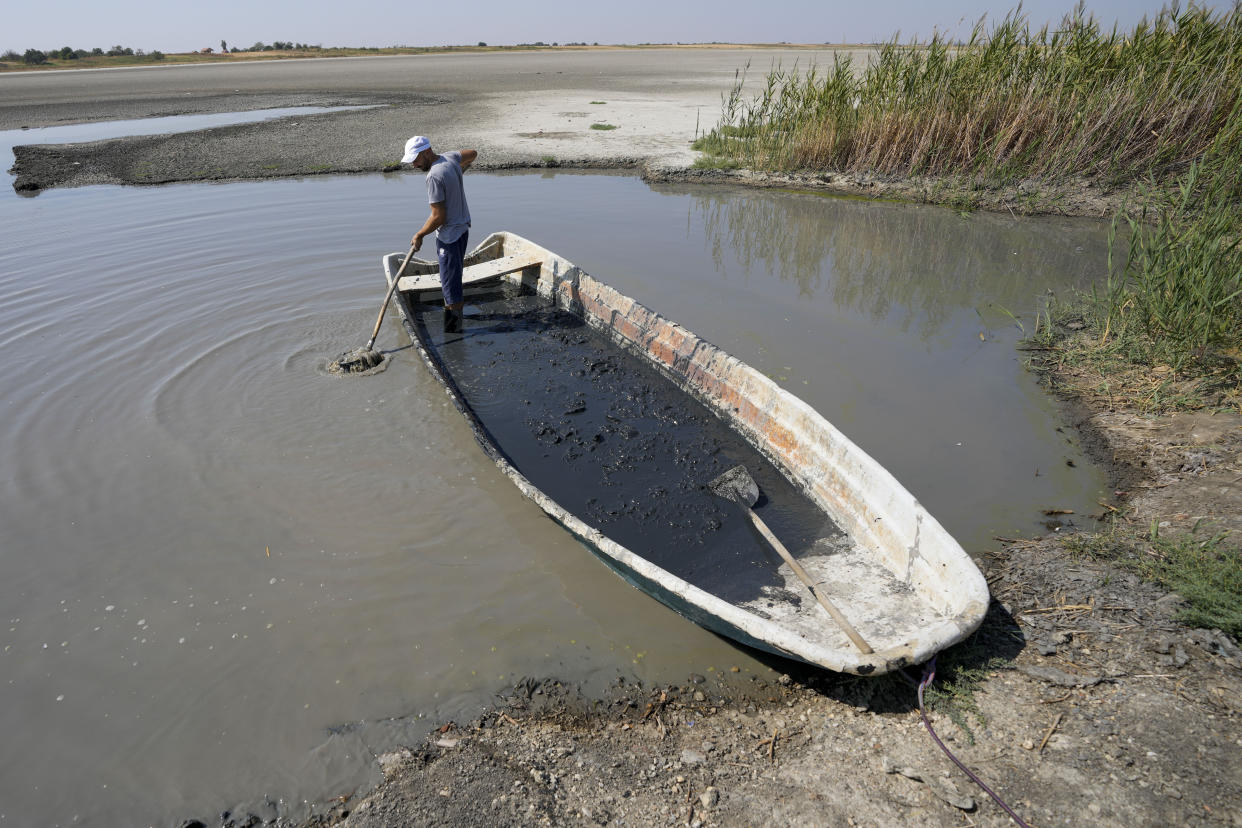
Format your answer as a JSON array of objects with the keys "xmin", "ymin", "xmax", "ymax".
[{"xmin": 385, "ymin": 233, "xmax": 989, "ymax": 675}]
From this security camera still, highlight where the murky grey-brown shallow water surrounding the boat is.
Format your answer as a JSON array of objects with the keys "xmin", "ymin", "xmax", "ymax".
[{"xmin": 0, "ymin": 160, "xmax": 1107, "ymax": 826}]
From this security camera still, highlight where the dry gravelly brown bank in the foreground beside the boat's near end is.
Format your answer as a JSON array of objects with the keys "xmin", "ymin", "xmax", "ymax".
[{"xmin": 264, "ymin": 398, "xmax": 1242, "ymax": 828}]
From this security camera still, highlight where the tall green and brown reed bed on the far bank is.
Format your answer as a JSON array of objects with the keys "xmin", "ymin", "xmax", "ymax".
[{"xmin": 699, "ymin": 5, "xmax": 1242, "ymax": 184}]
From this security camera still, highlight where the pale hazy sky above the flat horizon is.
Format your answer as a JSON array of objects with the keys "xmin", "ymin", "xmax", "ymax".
[{"xmin": 7, "ymin": 0, "xmax": 1232, "ymax": 52}]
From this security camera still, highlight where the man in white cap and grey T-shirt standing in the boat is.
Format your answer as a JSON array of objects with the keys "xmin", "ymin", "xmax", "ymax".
[{"xmin": 401, "ymin": 135, "xmax": 478, "ymax": 333}]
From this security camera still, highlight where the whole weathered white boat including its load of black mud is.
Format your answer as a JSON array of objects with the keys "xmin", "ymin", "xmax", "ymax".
[{"xmin": 384, "ymin": 232, "xmax": 989, "ymax": 675}]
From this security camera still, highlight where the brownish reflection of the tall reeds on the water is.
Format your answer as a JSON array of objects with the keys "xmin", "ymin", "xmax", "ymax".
[{"xmin": 692, "ymin": 190, "xmax": 1104, "ymax": 340}]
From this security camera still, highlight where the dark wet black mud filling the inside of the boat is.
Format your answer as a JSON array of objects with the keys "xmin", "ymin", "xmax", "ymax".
[{"xmin": 416, "ymin": 287, "xmax": 842, "ymax": 602}]
